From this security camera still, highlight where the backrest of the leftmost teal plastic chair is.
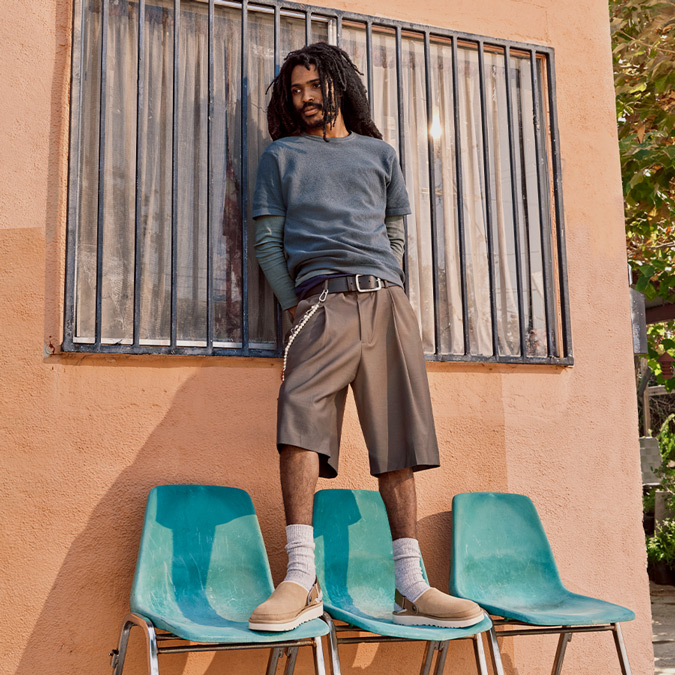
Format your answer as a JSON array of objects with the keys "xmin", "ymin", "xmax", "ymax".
[{"xmin": 130, "ymin": 485, "xmax": 273, "ymax": 621}]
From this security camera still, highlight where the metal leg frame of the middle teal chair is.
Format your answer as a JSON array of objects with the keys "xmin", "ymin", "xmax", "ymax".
[{"xmin": 322, "ymin": 612, "xmax": 504, "ymax": 675}]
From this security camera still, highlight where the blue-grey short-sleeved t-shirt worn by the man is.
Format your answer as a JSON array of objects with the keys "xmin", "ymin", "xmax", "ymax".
[{"xmin": 253, "ymin": 132, "xmax": 410, "ymax": 285}]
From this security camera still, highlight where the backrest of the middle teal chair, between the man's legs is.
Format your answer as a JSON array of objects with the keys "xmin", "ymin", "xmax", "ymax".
[{"xmin": 314, "ymin": 490, "xmax": 428, "ymax": 616}]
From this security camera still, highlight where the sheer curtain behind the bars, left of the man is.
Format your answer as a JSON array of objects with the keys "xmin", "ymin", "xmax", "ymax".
[{"xmin": 76, "ymin": 0, "xmax": 248, "ymax": 346}]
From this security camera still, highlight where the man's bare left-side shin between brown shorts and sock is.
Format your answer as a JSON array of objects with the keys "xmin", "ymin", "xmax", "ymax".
[{"xmin": 279, "ymin": 445, "xmax": 319, "ymax": 525}]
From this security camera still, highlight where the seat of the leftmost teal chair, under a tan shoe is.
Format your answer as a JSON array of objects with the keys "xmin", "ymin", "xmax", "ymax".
[{"xmin": 138, "ymin": 615, "xmax": 329, "ymax": 644}]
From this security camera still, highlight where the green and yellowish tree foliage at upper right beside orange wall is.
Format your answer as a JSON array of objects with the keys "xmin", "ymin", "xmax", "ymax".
[{"xmin": 609, "ymin": 0, "xmax": 675, "ymax": 380}]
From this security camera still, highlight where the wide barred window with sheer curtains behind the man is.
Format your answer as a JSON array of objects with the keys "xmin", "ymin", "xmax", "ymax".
[{"xmin": 63, "ymin": 0, "xmax": 572, "ymax": 364}]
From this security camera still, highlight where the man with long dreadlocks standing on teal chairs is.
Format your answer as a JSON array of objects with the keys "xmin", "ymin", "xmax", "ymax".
[{"xmin": 249, "ymin": 43, "xmax": 483, "ymax": 631}]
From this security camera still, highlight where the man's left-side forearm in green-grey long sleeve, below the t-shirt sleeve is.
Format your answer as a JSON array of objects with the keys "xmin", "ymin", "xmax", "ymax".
[{"xmin": 255, "ymin": 216, "xmax": 298, "ymax": 316}]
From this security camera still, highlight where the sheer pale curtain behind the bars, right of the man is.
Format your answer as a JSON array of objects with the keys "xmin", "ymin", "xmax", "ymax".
[{"xmin": 344, "ymin": 25, "xmax": 549, "ymax": 356}]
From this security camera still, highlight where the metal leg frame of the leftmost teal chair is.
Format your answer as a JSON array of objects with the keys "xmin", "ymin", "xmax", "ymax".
[{"xmin": 110, "ymin": 612, "xmax": 328, "ymax": 675}]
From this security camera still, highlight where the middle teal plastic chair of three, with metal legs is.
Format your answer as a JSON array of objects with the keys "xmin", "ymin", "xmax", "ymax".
[{"xmin": 314, "ymin": 490, "xmax": 503, "ymax": 675}]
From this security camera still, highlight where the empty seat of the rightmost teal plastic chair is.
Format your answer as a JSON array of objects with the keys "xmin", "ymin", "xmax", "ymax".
[{"xmin": 470, "ymin": 592, "xmax": 635, "ymax": 626}]
